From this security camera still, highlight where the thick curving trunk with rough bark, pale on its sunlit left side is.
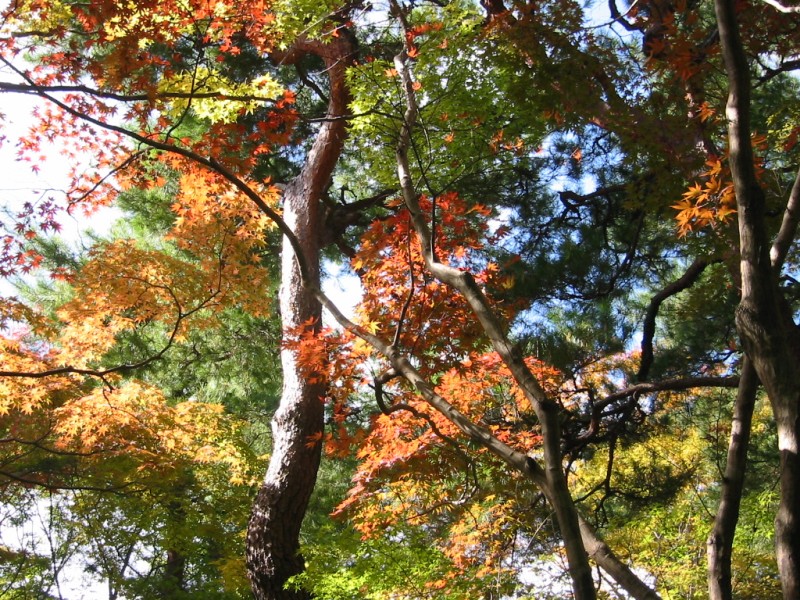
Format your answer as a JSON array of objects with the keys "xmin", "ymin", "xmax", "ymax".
[{"xmin": 247, "ymin": 36, "xmax": 351, "ymax": 600}]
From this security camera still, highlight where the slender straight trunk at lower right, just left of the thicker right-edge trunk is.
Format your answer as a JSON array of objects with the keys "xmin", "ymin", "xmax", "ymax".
[{"xmin": 706, "ymin": 356, "xmax": 758, "ymax": 600}]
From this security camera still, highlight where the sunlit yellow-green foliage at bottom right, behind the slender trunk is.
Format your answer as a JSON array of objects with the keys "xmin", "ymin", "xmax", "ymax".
[{"xmin": 576, "ymin": 392, "xmax": 780, "ymax": 600}]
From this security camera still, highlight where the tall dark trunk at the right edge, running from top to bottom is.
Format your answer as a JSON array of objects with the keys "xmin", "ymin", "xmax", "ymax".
[{"xmin": 715, "ymin": 0, "xmax": 800, "ymax": 600}]
